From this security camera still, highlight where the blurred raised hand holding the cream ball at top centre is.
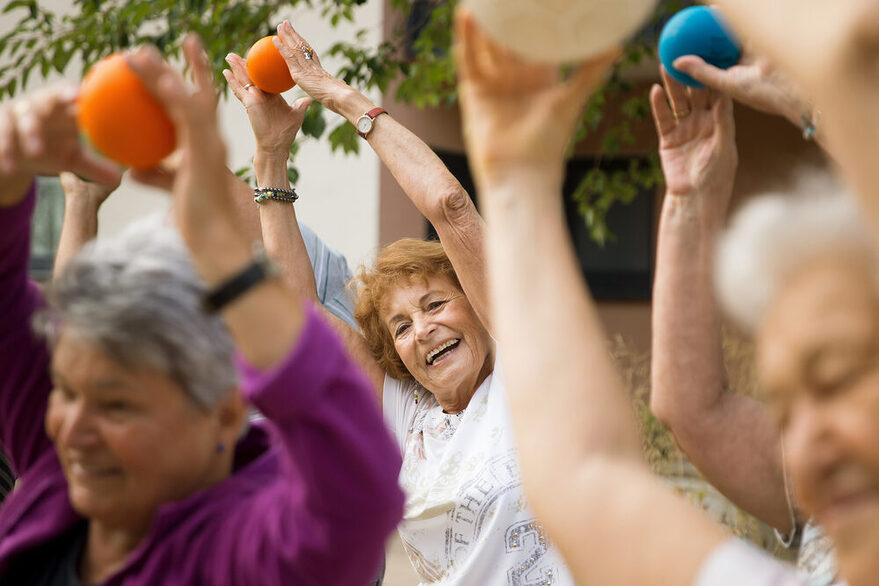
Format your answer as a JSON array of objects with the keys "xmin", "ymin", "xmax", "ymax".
[{"xmin": 455, "ymin": 9, "xmax": 617, "ymax": 187}]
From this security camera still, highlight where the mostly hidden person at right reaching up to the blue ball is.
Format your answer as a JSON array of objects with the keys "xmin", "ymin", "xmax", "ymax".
[{"xmin": 650, "ymin": 48, "xmax": 836, "ymax": 586}]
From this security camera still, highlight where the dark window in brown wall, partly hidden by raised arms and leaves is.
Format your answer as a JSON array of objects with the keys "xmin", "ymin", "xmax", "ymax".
[{"xmin": 427, "ymin": 151, "xmax": 654, "ymax": 301}]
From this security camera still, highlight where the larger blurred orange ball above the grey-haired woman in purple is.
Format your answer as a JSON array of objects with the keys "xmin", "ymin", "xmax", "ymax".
[{"xmin": 77, "ymin": 53, "xmax": 177, "ymax": 169}]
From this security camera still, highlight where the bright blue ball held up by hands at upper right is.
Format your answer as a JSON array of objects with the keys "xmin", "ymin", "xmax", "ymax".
[{"xmin": 659, "ymin": 6, "xmax": 742, "ymax": 87}]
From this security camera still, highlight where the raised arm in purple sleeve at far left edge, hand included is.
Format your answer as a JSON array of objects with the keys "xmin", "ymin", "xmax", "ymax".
[{"xmin": 0, "ymin": 86, "xmax": 118, "ymax": 474}]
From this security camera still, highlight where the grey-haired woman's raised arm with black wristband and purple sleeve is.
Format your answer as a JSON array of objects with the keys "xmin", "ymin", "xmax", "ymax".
[{"xmin": 130, "ymin": 38, "xmax": 402, "ymax": 585}]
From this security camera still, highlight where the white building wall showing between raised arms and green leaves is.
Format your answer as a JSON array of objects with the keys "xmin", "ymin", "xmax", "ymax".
[{"xmin": 0, "ymin": 0, "xmax": 383, "ymax": 266}]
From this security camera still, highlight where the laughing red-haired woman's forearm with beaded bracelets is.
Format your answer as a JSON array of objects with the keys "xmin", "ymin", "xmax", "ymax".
[{"xmin": 253, "ymin": 151, "xmax": 319, "ymax": 302}]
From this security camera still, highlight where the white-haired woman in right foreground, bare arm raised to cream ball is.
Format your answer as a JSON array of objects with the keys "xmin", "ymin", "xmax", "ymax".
[{"xmin": 458, "ymin": 8, "xmax": 879, "ymax": 586}]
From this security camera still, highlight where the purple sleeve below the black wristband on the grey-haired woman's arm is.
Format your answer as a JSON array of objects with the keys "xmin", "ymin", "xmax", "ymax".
[{"xmin": 219, "ymin": 307, "xmax": 403, "ymax": 586}]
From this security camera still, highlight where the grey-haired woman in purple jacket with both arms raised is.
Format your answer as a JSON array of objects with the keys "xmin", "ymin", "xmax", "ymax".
[{"xmin": 0, "ymin": 39, "xmax": 402, "ymax": 586}]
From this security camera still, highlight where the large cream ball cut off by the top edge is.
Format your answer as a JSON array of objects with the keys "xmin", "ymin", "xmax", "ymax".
[{"xmin": 466, "ymin": 0, "xmax": 655, "ymax": 63}]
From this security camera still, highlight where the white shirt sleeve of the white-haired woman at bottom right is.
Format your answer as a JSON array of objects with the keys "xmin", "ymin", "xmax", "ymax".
[{"xmin": 693, "ymin": 539, "xmax": 845, "ymax": 586}]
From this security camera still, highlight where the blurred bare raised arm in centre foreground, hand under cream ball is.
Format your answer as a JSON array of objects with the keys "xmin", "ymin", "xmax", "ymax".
[{"xmin": 458, "ymin": 13, "xmax": 724, "ymax": 586}]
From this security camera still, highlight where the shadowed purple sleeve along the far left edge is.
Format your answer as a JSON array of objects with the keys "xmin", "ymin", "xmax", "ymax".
[{"xmin": 0, "ymin": 185, "xmax": 52, "ymax": 475}]
